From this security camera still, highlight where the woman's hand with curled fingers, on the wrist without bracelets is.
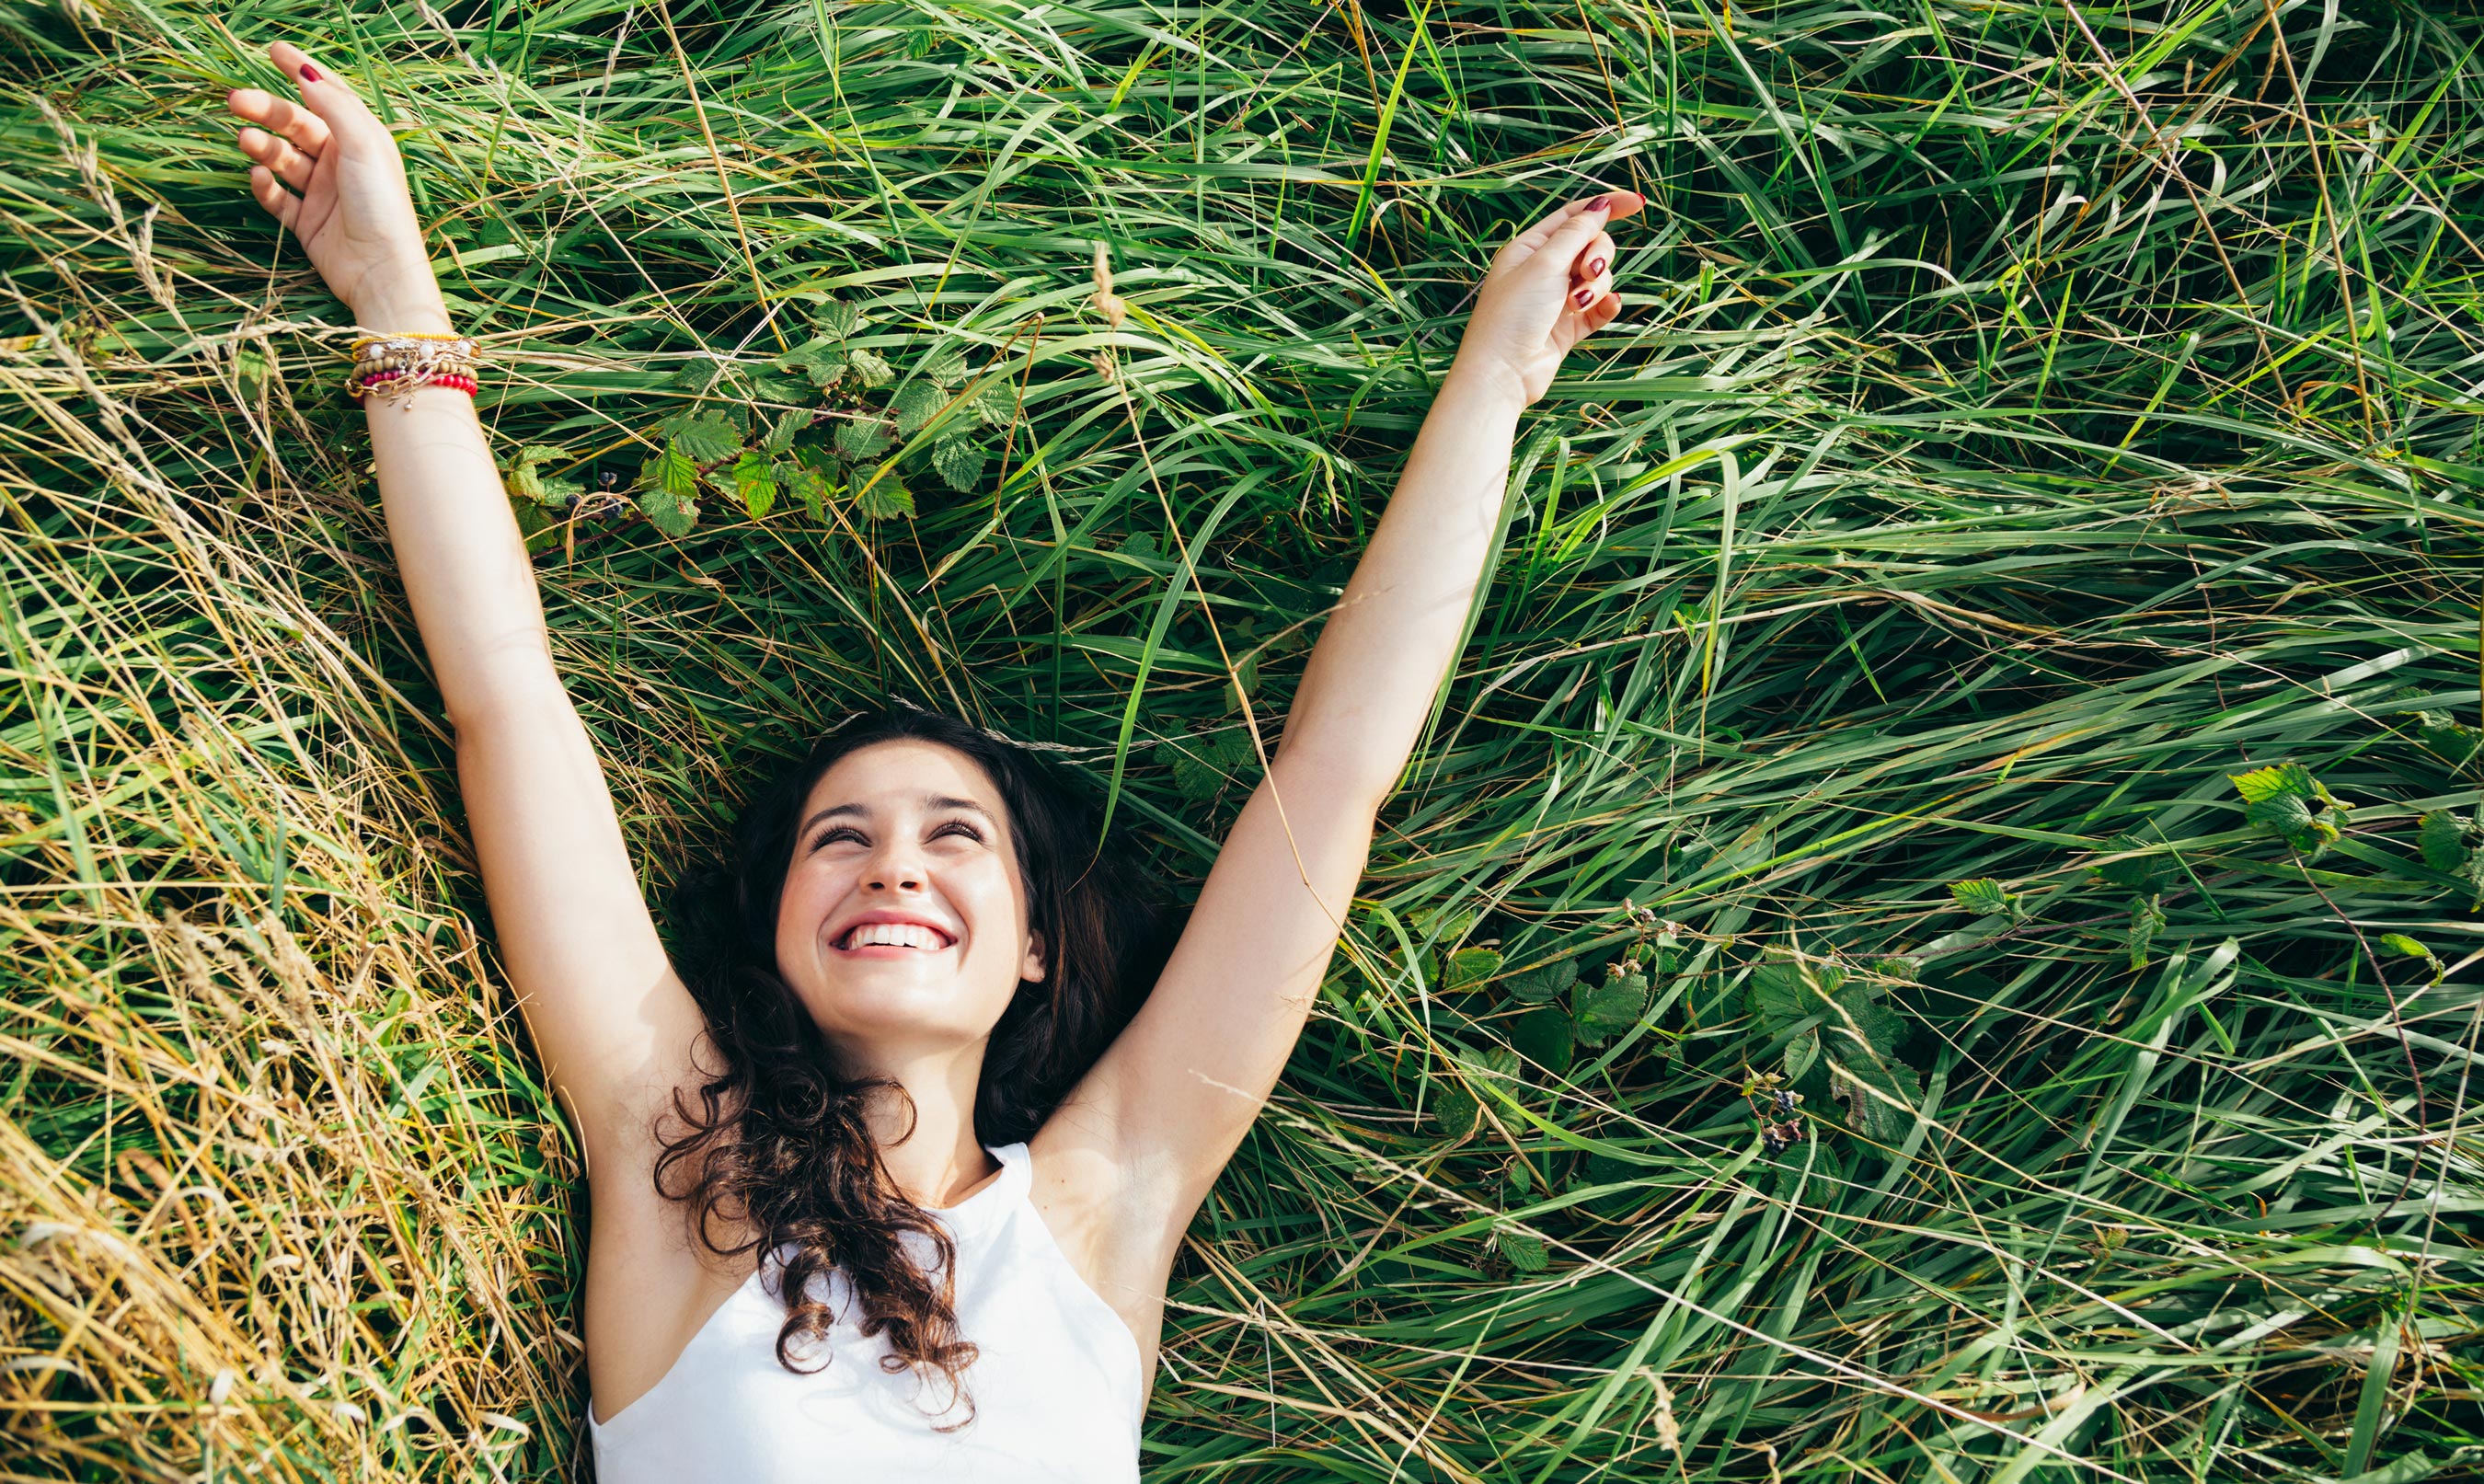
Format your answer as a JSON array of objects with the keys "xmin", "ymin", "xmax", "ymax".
[{"xmin": 1454, "ymin": 191, "xmax": 1647, "ymax": 403}]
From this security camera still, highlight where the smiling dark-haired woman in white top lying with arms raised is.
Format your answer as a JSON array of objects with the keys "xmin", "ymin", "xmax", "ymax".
[{"xmin": 228, "ymin": 42, "xmax": 1642, "ymax": 1484}]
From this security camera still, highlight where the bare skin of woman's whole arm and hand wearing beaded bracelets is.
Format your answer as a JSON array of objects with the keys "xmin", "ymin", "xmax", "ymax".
[{"xmin": 228, "ymin": 42, "xmax": 703, "ymax": 1173}]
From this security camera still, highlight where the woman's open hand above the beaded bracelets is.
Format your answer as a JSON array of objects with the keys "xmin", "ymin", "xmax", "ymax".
[{"xmin": 224, "ymin": 42, "xmax": 450, "ymax": 333}]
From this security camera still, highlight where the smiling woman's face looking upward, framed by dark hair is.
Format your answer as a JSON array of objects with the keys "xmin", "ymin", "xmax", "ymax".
[{"xmin": 775, "ymin": 741, "xmax": 1043, "ymax": 1066}]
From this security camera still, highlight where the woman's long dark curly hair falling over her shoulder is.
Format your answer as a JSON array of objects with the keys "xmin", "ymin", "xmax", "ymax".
[{"xmin": 656, "ymin": 706, "xmax": 1175, "ymax": 1427}]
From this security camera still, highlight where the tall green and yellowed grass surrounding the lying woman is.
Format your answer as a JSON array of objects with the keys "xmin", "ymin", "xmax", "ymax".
[{"xmin": 0, "ymin": 0, "xmax": 2484, "ymax": 1484}]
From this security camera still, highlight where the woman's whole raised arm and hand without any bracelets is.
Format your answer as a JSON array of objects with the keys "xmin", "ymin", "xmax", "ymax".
[{"xmin": 1036, "ymin": 191, "xmax": 1642, "ymax": 1237}]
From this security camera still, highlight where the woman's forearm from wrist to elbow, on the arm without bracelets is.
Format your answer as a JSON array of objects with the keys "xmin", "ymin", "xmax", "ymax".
[{"xmin": 1284, "ymin": 365, "xmax": 1525, "ymax": 785}]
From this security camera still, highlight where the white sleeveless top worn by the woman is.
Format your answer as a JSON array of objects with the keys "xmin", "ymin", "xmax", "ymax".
[{"xmin": 586, "ymin": 1144, "xmax": 1145, "ymax": 1484}]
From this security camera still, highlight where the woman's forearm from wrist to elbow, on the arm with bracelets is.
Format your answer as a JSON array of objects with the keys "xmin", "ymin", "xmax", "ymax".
[{"xmin": 362, "ymin": 316, "xmax": 557, "ymax": 723}]
